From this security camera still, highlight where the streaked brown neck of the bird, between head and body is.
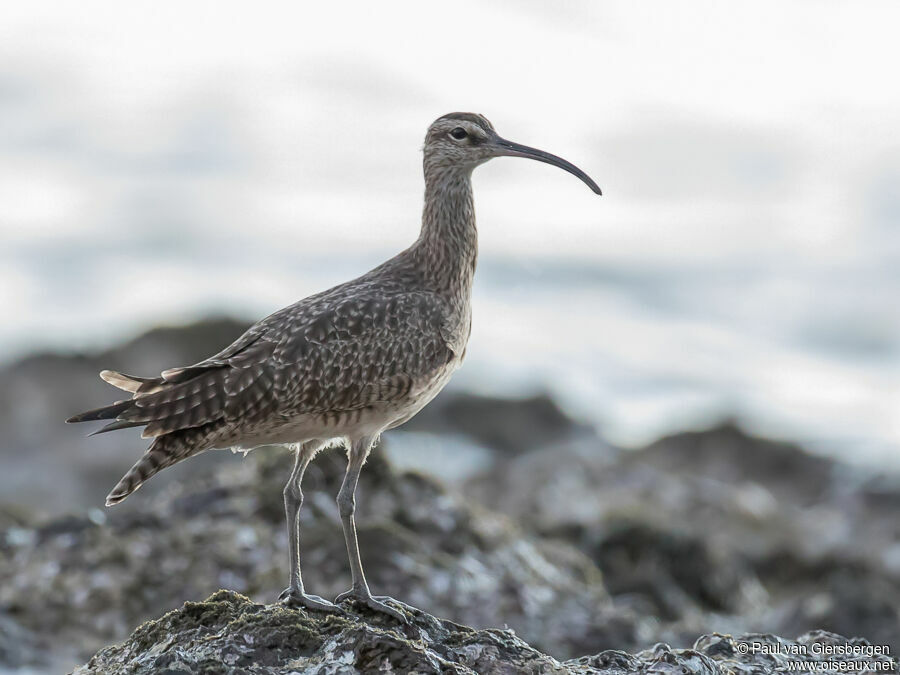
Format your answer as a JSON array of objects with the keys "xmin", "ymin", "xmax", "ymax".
[{"xmin": 415, "ymin": 162, "xmax": 478, "ymax": 300}]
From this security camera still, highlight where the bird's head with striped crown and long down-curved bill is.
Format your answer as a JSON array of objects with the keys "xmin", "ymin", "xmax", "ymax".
[{"xmin": 425, "ymin": 113, "xmax": 601, "ymax": 195}]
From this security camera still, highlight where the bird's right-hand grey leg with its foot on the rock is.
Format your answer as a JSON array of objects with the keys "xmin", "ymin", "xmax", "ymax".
[{"xmin": 335, "ymin": 438, "xmax": 408, "ymax": 623}]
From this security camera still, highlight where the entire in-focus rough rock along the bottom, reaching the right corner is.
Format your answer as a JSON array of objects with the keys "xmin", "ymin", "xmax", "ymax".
[{"xmin": 74, "ymin": 591, "xmax": 897, "ymax": 675}]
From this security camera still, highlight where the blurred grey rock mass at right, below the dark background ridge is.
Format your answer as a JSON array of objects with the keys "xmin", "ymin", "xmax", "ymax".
[{"xmin": 464, "ymin": 423, "xmax": 900, "ymax": 650}]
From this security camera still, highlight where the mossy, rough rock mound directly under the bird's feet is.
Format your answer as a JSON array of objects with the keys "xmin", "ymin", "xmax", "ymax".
[{"xmin": 75, "ymin": 591, "xmax": 566, "ymax": 675}]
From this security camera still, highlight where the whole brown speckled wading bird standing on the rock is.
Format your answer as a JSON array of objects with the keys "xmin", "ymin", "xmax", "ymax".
[{"xmin": 67, "ymin": 112, "xmax": 601, "ymax": 623}]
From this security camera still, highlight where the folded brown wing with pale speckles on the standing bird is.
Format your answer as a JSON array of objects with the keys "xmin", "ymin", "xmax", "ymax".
[{"xmin": 110, "ymin": 293, "xmax": 453, "ymax": 438}]
